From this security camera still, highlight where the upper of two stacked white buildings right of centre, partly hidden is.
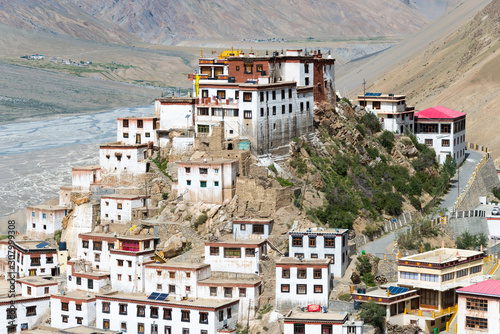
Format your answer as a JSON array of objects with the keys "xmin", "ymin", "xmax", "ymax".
[{"xmin": 288, "ymin": 228, "xmax": 349, "ymax": 278}]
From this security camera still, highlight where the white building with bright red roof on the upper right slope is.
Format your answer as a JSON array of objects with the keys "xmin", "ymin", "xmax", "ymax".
[{"xmin": 415, "ymin": 106, "xmax": 466, "ymax": 165}]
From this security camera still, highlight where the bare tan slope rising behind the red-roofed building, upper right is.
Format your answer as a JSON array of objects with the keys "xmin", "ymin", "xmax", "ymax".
[{"xmin": 372, "ymin": 0, "xmax": 500, "ymax": 162}]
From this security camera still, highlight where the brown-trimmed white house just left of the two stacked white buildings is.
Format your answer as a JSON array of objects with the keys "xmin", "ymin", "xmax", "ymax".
[{"xmin": 205, "ymin": 239, "xmax": 267, "ymax": 275}]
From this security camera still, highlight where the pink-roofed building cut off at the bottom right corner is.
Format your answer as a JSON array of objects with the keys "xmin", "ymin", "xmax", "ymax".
[{"xmin": 457, "ymin": 280, "xmax": 500, "ymax": 334}]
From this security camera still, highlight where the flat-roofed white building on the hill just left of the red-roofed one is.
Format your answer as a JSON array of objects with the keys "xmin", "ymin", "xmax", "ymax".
[{"xmin": 357, "ymin": 93, "xmax": 415, "ymax": 134}]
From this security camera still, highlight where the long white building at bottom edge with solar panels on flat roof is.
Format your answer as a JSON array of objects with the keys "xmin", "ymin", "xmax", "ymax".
[{"xmin": 96, "ymin": 292, "xmax": 238, "ymax": 334}]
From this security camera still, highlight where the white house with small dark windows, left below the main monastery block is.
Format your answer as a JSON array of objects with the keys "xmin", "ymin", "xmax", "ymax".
[{"xmin": 99, "ymin": 143, "xmax": 149, "ymax": 174}]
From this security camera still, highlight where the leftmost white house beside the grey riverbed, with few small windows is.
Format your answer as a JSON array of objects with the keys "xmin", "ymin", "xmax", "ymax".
[{"xmin": 26, "ymin": 204, "xmax": 68, "ymax": 239}]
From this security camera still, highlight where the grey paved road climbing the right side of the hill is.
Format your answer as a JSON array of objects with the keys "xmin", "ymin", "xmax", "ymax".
[{"xmin": 361, "ymin": 150, "xmax": 484, "ymax": 257}]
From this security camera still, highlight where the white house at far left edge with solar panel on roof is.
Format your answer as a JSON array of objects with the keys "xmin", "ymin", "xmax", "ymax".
[{"xmin": 13, "ymin": 241, "xmax": 59, "ymax": 277}]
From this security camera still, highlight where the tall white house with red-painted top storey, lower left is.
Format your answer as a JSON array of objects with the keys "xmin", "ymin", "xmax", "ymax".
[{"xmin": 110, "ymin": 235, "xmax": 160, "ymax": 292}]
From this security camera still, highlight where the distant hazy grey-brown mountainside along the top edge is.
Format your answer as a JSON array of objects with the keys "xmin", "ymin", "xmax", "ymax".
[{"xmin": 0, "ymin": 0, "xmax": 459, "ymax": 44}]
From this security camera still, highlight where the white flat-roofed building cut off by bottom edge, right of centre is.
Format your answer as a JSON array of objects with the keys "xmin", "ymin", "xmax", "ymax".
[{"xmin": 283, "ymin": 310, "xmax": 363, "ymax": 334}]
